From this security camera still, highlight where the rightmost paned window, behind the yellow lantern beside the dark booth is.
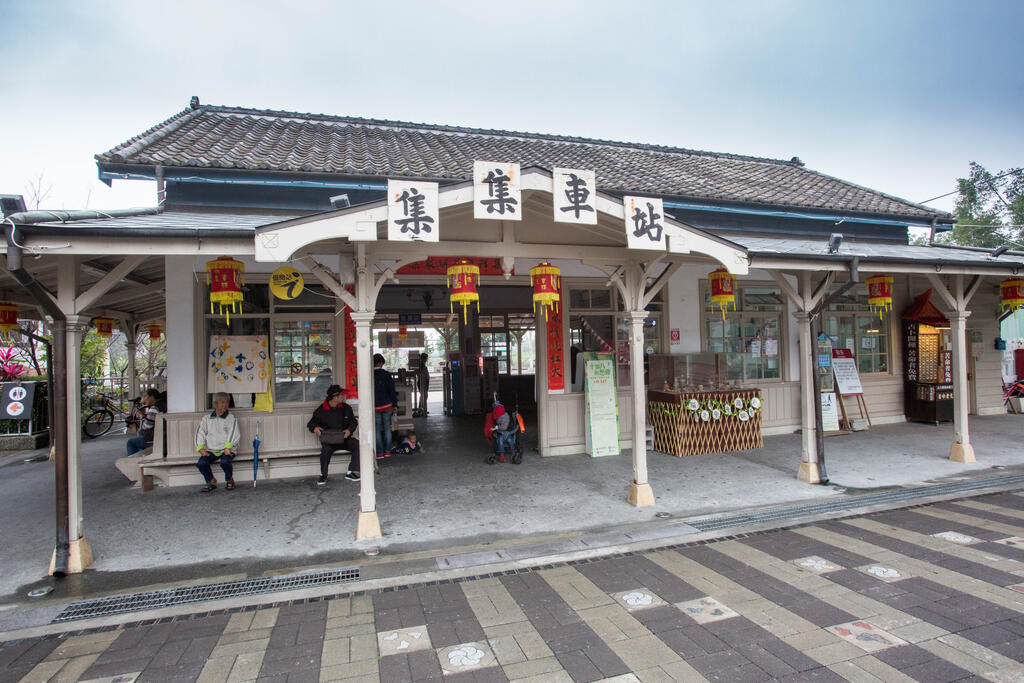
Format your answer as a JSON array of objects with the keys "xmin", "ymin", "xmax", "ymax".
[{"xmin": 823, "ymin": 285, "xmax": 890, "ymax": 375}]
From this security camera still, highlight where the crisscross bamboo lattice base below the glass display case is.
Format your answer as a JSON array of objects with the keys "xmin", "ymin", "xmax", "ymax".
[{"xmin": 647, "ymin": 389, "xmax": 764, "ymax": 458}]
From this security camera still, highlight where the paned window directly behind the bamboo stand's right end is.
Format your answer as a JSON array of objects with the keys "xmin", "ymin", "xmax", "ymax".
[{"xmin": 702, "ymin": 282, "xmax": 785, "ymax": 381}]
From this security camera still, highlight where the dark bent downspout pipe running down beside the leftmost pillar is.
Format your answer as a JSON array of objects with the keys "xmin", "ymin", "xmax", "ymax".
[{"xmin": 5, "ymin": 222, "xmax": 71, "ymax": 577}]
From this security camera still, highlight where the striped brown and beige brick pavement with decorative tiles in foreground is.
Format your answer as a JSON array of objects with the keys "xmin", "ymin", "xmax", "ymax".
[{"xmin": 0, "ymin": 494, "xmax": 1024, "ymax": 683}]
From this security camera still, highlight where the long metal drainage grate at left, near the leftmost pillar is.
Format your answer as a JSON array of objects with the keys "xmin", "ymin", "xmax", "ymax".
[{"xmin": 51, "ymin": 567, "xmax": 359, "ymax": 624}]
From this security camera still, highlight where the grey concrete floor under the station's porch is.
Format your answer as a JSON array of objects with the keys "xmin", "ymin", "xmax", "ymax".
[{"xmin": 0, "ymin": 415, "xmax": 1024, "ymax": 596}]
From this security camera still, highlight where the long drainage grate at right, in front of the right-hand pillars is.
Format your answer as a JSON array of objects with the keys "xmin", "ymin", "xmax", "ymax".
[{"xmin": 686, "ymin": 474, "xmax": 1024, "ymax": 531}]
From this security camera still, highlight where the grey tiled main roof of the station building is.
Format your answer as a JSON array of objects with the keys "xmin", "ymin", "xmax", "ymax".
[{"xmin": 96, "ymin": 104, "xmax": 951, "ymax": 222}]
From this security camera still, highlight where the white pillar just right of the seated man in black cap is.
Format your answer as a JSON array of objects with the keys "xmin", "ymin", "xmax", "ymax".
[{"xmin": 352, "ymin": 310, "xmax": 381, "ymax": 541}]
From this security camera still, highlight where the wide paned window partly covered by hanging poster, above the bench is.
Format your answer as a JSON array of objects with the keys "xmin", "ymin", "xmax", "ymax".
[{"xmin": 204, "ymin": 283, "xmax": 335, "ymax": 403}]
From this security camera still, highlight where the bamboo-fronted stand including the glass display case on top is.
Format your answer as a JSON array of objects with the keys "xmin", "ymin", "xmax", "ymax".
[{"xmin": 647, "ymin": 353, "xmax": 764, "ymax": 458}]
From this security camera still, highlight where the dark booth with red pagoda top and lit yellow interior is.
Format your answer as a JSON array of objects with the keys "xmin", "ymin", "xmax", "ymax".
[{"xmin": 903, "ymin": 290, "xmax": 953, "ymax": 424}]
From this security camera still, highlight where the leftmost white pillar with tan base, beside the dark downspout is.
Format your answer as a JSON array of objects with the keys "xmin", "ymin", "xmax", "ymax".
[{"xmin": 65, "ymin": 315, "xmax": 92, "ymax": 573}]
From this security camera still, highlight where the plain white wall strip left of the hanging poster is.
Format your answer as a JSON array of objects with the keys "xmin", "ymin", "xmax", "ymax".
[{"xmin": 164, "ymin": 256, "xmax": 197, "ymax": 413}]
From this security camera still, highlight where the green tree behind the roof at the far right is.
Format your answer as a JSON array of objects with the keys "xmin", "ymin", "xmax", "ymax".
[{"xmin": 950, "ymin": 162, "xmax": 1024, "ymax": 248}]
